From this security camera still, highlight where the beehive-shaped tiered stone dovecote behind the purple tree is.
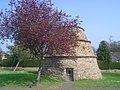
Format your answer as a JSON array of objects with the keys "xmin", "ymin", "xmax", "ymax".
[{"xmin": 42, "ymin": 28, "xmax": 102, "ymax": 81}]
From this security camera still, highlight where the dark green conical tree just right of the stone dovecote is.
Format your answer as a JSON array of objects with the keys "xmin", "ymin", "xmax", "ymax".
[{"xmin": 97, "ymin": 41, "xmax": 111, "ymax": 68}]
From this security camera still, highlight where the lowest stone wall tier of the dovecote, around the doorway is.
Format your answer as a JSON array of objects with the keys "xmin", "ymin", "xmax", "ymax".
[{"xmin": 42, "ymin": 57, "xmax": 102, "ymax": 80}]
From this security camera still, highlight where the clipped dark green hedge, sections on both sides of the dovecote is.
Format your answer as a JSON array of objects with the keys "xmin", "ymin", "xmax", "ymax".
[{"xmin": 0, "ymin": 58, "xmax": 120, "ymax": 70}]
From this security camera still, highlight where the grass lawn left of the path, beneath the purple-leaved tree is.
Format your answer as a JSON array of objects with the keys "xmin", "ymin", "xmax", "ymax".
[{"xmin": 0, "ymin": 70, "xmax": 64, "ymax": 88}]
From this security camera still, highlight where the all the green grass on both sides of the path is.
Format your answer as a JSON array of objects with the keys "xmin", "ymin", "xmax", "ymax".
[{"xmin": 0, "ymin": 70, "xmax": 120, "ymax": 88}]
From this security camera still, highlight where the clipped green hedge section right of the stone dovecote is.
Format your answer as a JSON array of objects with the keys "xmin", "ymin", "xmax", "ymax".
[{"xmin": 98, "ymin": 61, "xmax": 120, "ymax": 70}]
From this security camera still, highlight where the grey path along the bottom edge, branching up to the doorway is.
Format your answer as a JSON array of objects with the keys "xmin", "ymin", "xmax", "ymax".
[{"xmin": 0, "ymin": 82, "xmax": 120, "ymax": 90}]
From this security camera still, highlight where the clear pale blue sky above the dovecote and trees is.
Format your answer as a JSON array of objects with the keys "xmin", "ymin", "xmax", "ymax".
[{"xmin": 0, "ymin": 0, "xmax": 120, "ymax": 51}]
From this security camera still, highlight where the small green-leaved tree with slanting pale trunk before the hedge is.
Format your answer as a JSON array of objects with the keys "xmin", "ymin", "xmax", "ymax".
[{"xmin": 7, "ymin": 45, "xmax": 33, "ymax": 71}]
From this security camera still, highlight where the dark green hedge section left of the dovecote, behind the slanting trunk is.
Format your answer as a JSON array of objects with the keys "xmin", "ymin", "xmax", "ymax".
[{"xmin": 0, "ymin": 58, "xmax": 39, "ymax": 67}]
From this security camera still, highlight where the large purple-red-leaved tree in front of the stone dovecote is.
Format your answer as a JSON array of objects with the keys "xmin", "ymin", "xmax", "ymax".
[{"xmin": 0, "ymin": 0, "xmax": 79, "ymax": 85}]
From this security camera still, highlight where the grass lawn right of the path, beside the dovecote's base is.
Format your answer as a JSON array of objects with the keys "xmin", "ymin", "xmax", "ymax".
[{"xmin": 74, "ymin": 72, "xmax": 120, "ymax": 88}]
